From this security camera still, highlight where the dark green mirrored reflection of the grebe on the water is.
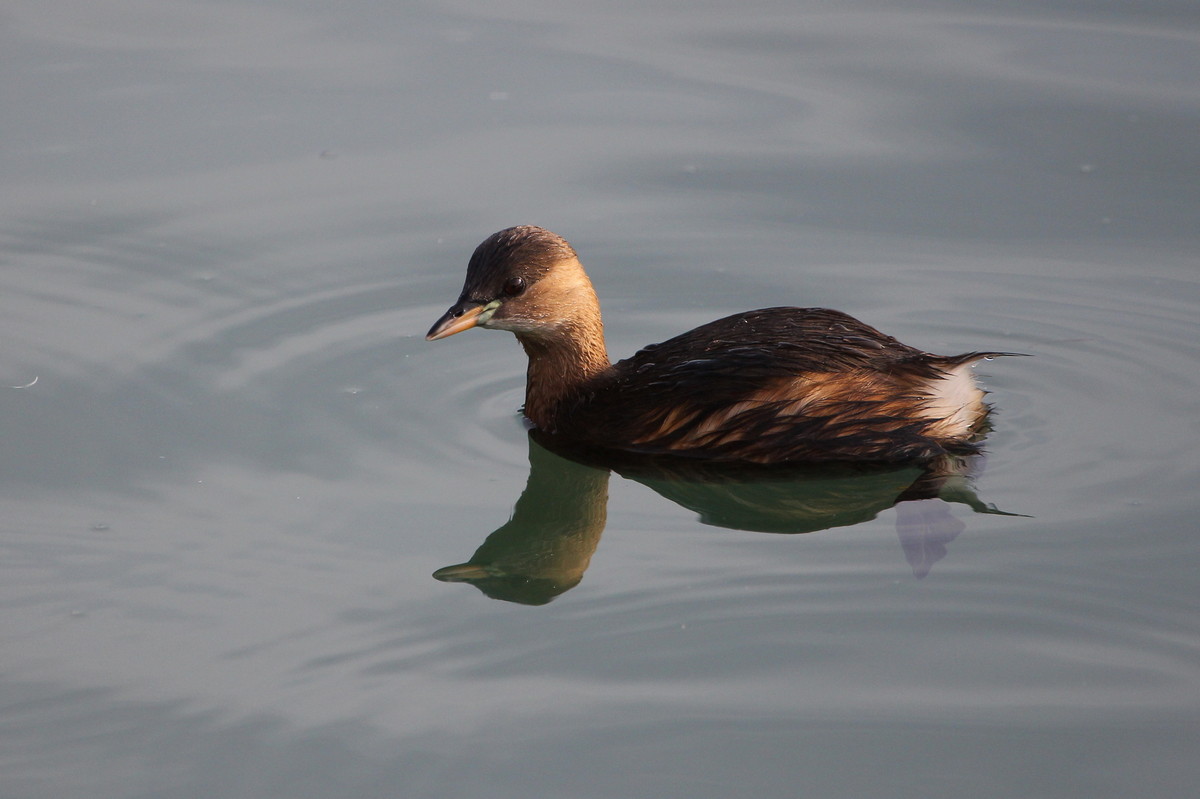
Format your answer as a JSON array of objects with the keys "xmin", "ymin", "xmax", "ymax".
[{"xmin": 433, "ymin": 431, "xmax": 1009, "ymax": 605}]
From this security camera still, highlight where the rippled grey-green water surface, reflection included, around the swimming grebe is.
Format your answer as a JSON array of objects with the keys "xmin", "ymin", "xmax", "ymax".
[{"xmin": 0, "ymin": 0, "xmax": 1200, "ymax": 799}]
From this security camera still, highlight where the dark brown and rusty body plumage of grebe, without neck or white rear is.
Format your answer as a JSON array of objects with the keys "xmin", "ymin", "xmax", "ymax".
[{"xmin": 559, "ymin": 308, "xmax": 985, "ymax": 462}]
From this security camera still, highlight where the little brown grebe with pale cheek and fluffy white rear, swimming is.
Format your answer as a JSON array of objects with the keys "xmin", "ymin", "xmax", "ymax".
[{"xmin": 426, "ymin": 226, "xmax": 1004, "ymax": 464}]
